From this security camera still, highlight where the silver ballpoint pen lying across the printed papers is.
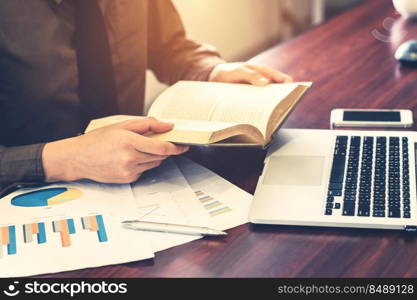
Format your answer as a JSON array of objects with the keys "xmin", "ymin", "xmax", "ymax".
[{"xmin": 122, "ymin": 220, "xmax": 227, "ymax": 236}]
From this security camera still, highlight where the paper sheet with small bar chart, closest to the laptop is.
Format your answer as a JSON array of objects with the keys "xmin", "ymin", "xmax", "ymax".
[{"xmin": 175, "ymin": 157, "xmax": 253, "ymax": 230}]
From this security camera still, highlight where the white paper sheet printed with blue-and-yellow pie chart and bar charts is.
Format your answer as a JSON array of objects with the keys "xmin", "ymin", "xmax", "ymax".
[{"xmin": 0, "ymin": 181, "xmax": 153, "ymax": 277}]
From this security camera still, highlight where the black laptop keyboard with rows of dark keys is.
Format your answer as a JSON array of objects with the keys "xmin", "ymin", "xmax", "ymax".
[{"xmin": 324, "ymin": 136, "xmax": 411, "ymax": 218}]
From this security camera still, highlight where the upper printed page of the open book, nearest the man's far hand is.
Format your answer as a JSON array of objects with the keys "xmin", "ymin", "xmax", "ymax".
[{"xmin": 148, "ymin": 81, "xmax": 300, "ymax": 136}]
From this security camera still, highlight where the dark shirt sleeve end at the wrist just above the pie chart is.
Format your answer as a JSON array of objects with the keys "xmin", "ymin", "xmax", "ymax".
[{"xmin": 0, "ymin": 144, "xmax": 45, "ymax": 190}]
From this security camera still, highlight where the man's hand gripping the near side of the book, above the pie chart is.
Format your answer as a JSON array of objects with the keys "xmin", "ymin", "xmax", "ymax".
[{"xmin": 42, "ymin": 118, "xmax": 188, "ymax": 183}]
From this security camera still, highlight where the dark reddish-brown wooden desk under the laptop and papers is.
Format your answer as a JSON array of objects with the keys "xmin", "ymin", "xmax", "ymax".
[{"xmin": 44, "ymin": 0, "xmax": 417, "ymax": 277}]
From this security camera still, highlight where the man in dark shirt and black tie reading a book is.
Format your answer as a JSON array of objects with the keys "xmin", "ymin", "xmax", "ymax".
[{"xmin": 0, "ymin": 0, "xmax": 291, "ymax": 193}]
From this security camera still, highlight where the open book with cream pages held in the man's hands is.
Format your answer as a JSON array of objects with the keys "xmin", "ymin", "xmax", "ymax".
[{"xmin": 86, "ymin": 81, "xmax": 311, "ymax": 146}]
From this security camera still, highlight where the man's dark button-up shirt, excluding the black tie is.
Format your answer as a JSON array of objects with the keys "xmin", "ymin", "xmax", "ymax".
[{"xmin": 0, "ymin": 0, "xmax": 223, "ymax": 188}]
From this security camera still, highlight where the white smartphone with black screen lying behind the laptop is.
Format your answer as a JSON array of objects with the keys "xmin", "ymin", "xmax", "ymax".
[{"xmin": 330, "ymin": 108, "xmax": 413, "ymax": 128}]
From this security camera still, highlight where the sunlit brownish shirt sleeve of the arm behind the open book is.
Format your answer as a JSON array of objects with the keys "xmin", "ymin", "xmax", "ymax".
[{"xmin": 148, "ymin": 0, "xmax": 225, "ymax": 84}]
